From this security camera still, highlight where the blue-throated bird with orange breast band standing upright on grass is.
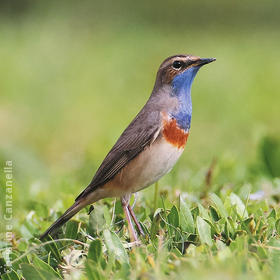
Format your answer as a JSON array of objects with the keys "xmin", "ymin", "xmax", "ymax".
[{"xmin": 40, "ymin": 54, "xmax": 216, "ymax": 242}]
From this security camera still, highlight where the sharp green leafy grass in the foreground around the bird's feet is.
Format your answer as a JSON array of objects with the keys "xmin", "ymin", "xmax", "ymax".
[{"xmin": 2, "ymin": 173, "xmax": 280, "ymax": 279}]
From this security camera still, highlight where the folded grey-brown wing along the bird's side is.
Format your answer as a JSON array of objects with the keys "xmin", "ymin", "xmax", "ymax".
[{"xmin": 76, "ymin": 106, "xmax": 161, "ymax": 200}]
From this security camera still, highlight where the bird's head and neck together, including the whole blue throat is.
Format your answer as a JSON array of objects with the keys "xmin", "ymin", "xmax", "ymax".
[{"xmin": 151, "ymin": 55, "xmax": 216, "ymax": 131}]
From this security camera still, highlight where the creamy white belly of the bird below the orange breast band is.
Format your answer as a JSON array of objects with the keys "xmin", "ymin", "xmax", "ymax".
[{"xmin": 121, "ymin": 138, "xmax": 184, "ymax": 193}]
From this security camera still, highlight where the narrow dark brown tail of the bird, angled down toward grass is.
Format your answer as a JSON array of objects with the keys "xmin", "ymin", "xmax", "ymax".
[{"xmin": 40, "ymin": 200, "xmax": 85, "ymax": 240}]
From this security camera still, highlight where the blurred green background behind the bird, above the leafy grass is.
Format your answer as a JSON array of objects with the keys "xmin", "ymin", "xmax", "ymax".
[{"xmin": 0, "ymin": 0, "xmax": 280, "ymax": 224}]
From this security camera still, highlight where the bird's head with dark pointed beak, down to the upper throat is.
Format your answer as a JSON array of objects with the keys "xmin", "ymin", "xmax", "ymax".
[{"xmin": 155, "ymin": 55, "xmax": 216, "ymax": 94}]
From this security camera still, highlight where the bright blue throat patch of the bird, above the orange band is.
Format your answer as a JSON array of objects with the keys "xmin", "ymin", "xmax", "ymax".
[{"xmin": 171, "ymin": 66, "xmax": 200, "ymax": 130}]
